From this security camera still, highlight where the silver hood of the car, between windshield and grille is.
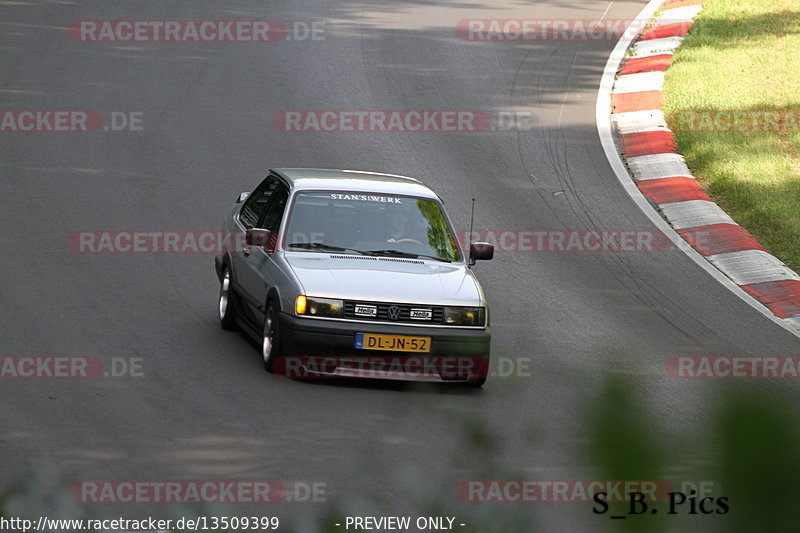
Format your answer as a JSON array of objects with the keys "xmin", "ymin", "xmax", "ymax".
[{"xmin": 285, "ymin": 252, "xmax": 483, "ymax": 306}]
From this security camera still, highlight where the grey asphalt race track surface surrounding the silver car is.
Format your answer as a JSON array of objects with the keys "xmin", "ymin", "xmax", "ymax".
[{"xmin": 0, "ymin": 0, "xmax": 800, "ymax": 531}]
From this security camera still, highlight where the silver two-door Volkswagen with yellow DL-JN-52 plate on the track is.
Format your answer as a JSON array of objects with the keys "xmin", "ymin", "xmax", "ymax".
[{"xmin": 215, "ymin": 168, "xmax": 494, "ymax": 387}]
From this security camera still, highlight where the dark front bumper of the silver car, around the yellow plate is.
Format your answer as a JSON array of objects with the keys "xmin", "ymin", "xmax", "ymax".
[{"xmin": 279, "ymin": 312, "xmax": 491, "ymax": 381}]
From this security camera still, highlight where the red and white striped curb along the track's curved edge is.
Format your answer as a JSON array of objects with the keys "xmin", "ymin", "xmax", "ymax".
[{"xmin": 596, "ymin": 0, "xmax": 800, "ymax": 335}]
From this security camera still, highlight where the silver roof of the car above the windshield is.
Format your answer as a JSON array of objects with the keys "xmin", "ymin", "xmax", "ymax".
[{"xmin": 272, "ymin": 168, "xmax": 441, "ymax": 200}]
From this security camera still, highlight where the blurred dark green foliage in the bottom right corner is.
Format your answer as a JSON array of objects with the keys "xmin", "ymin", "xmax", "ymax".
[{"xmin": 587, "ymin": 378, "xmax": 800, "ymax": 533}]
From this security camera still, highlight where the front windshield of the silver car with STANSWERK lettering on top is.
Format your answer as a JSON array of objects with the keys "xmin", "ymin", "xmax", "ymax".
[{"xmin": 284, "ymin": 192, "xmax": 461, "ymax": 262}]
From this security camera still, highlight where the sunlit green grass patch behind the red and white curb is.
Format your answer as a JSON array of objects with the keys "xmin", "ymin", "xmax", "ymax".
[{"xmin": 664, "ymin": 0, "xmax": 800, "ymax": 270}]
